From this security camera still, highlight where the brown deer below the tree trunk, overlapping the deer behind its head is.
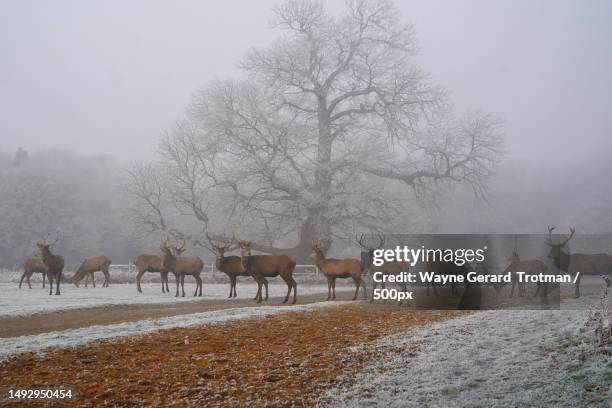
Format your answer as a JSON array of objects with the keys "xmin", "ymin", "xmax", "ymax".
[{"xmin": 236, "ymin": 239, "xmax": 297, "ymax": 304}]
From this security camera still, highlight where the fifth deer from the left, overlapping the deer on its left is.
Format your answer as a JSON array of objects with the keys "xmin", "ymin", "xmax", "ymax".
[{"xmin": 159, "ymin": 239, "xmax": 204, "ymax": 297}]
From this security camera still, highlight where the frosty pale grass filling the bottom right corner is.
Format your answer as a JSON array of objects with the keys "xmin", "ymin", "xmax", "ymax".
[{"xmin": 322, "ymin": 296, "xmax": 612, "ymax": 407}]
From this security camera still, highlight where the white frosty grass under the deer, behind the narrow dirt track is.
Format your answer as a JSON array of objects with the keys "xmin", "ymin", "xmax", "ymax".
[{"xmin": 0, "ymin": 282, "xmax": 348, "ymax": 317}]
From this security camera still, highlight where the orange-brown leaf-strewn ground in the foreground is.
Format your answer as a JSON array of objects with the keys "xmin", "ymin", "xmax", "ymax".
[{"xmin": 0, "ymin": 304, "xmax": 462, "ymax": 406}]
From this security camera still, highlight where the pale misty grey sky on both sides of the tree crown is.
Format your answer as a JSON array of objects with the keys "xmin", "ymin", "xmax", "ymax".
[{"xmin": 0, "ymin": 0, "xmax": 612, "ymax": 163}]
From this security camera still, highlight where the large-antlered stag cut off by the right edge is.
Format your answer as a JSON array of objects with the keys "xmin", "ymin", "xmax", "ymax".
[{"xmin": 546, "ymin": 226, "xmax": 612, "ymax": 298}]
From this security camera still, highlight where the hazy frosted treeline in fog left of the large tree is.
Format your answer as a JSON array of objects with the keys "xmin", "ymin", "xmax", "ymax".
[{"xmin": 0, "ymin": 149, "xmax": 142, "ymax": 269}]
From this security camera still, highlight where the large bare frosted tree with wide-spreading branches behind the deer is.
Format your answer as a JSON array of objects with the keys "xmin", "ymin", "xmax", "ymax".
[{"xmin": 129, "ymin": 0, "xmax": 500, "ymax": 259}]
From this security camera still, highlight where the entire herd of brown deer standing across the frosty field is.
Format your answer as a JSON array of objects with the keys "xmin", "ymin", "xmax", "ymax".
[{"xmin": 19, "ymin": 227, "xmax": 612, "ymax": 303}]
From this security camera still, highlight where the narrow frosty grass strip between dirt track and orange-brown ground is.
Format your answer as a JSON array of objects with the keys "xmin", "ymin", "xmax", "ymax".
[{"xmin": 0, "ymin": 302, "xmax": 338, "ymax": 361}]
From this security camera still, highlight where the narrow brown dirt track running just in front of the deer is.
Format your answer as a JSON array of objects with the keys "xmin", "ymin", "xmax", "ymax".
[{"xmin": 0, "ymin": 292, "xmax": 340, "ymax": 338}]
